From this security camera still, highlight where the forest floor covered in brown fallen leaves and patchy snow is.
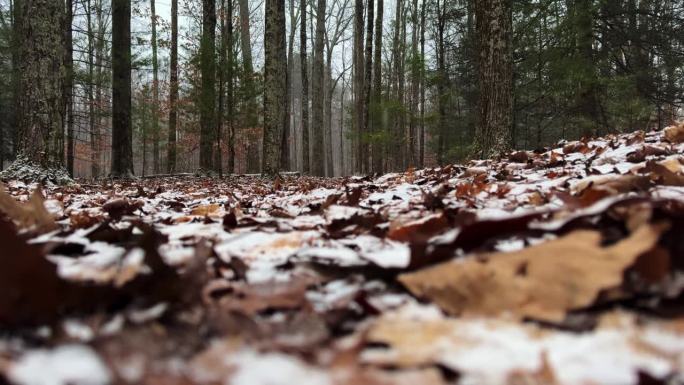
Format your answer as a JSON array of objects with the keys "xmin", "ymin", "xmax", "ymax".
[{"xmin": 0, "ymin": 125, "xmax": 684, "ymax": 385}]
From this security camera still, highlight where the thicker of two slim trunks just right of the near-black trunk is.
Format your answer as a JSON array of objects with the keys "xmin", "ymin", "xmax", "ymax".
[{"xmin": 166, "ymin": 0, "xmax": 178, "ymax": 174}]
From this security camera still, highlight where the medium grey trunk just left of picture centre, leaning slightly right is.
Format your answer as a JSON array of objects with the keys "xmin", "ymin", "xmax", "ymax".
[{"xmin": 311, "ymin": 0, "xmax": 326, "ymax": 176}]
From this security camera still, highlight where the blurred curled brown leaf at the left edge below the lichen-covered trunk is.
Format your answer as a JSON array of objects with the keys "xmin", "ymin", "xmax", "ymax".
[{"xmin": 0, "ymin": 183, "xmax": 58, "ymax": 232}]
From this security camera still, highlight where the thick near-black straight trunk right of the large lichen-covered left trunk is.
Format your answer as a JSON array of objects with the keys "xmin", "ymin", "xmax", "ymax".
[{"xmin": 112, "ymin": 0, "xmax": 133, "ymax": 178}]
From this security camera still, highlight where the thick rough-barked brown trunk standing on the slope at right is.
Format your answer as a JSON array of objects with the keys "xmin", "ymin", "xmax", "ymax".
[{"xmin": 474, "ymin": 0, "xmax": 513, "ymax": 158}]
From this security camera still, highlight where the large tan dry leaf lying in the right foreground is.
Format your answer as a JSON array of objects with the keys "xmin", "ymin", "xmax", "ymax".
[{"xmin": 399, "ymin": 225, "xmax": 666, "ymax": 322}]
